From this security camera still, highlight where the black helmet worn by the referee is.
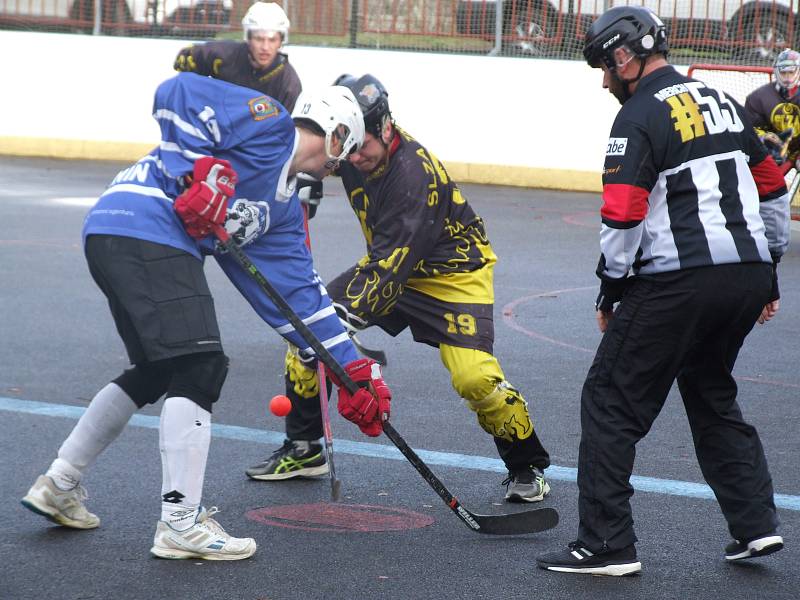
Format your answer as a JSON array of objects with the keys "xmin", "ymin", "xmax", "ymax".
[{"xmin": 583, "ymin": 6, "xmax": 669, "ymax": 71}]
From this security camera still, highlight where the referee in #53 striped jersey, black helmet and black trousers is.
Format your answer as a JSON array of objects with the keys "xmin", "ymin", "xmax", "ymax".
[{"xmin": 538, "ymin": 6, "xmax": 789, "ymax": 575}]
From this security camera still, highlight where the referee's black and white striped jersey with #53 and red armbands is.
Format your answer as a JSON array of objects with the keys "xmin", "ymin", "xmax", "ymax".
[{"xmin": 597, "ymin": 66, "xmax": 789, "ymax": 281}]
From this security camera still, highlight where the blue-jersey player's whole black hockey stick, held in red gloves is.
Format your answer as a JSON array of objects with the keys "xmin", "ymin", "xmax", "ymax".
[{"xmin": 215, "ymin": 226, "xmax": 558, "ymax": 535}]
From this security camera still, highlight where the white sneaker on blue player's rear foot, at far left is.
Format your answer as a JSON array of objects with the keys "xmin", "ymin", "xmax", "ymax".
[{"xmin": 22, "ymin": 475, "xmax": 100, "ymax": 529}]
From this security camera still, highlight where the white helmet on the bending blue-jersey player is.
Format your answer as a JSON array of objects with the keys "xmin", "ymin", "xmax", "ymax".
[{"xmin": 292, "ymin": 85, "xmax": 364, "ymax": 161}]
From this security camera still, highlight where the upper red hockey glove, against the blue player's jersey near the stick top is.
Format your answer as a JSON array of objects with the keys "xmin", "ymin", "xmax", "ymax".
[{"xmin": 175, "ymin": 156, "xmax": 237, "ymax": 239}]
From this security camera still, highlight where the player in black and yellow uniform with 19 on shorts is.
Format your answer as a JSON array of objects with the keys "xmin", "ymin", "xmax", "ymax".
[{"xmin": 246, "ymin": 75, "xmax": 550, "ymax": 502}]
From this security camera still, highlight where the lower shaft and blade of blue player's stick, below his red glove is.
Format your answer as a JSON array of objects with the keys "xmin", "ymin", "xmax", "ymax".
[{"xmin": 383, "ymin": 421, "xmax": 558, "ymax": 535}]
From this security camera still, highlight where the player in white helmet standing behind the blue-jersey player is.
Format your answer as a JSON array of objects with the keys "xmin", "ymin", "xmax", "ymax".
[{"xmin": 174, "ymin": 2, "xmax": 302, "ymax": 112}]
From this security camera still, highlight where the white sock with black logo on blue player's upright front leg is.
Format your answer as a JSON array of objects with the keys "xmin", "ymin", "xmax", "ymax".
[{"xmin": 159, "ymin": 397, "xmax": 211, "ymax": 530}]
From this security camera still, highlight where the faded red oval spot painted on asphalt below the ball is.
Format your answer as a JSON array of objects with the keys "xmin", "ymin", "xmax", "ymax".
[{"xmin": 245, "ymin": 502, "xmax": 434, "ymax": 532}]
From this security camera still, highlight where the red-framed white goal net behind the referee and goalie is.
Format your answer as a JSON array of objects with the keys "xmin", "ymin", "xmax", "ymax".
[{"xmin": 688, "ymin": 64, "xmax": 800, "ymax": 221}]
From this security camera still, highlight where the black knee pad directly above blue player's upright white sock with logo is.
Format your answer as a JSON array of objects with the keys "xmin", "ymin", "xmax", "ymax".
[{"xmin": 167, "ymin": 352, "xmax": 229, "ymax": 412}]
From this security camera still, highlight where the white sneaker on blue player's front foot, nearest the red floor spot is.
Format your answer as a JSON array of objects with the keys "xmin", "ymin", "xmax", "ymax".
[{"xmin": 150, "ymin": 506, "xmax": 256, "ymax": 560}]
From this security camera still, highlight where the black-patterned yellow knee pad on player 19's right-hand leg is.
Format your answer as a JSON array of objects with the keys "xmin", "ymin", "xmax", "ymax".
[{"xmin": 467, "ymin": 381, "xmax": 533, "ymax": 442}]
